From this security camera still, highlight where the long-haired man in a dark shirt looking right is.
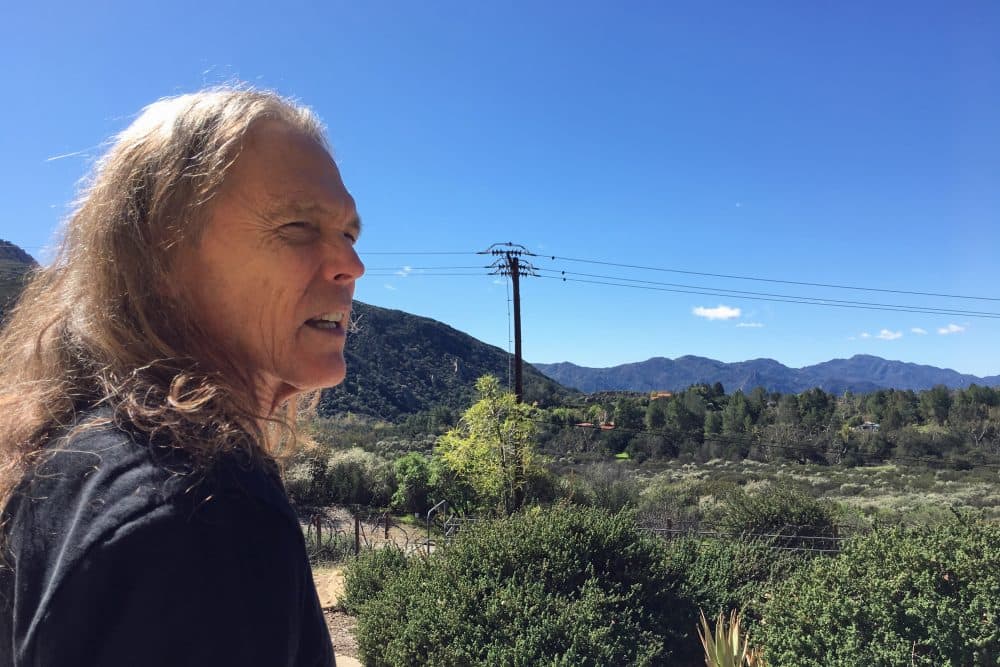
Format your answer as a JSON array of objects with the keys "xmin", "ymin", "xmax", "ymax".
[{"xmin": 0, "ymin": 88, "xmax": 364, "ymax": 667}]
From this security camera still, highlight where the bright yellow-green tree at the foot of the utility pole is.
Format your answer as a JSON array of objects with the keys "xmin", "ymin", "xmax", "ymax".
[{"xmin": 435, "ymin": 375, "xmax": 537, "ymax": 514}]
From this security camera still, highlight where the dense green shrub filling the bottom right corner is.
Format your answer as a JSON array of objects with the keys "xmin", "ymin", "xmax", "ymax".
[{"xmin": 758, "ymin": 520, "xmax": 1000, "ymax": 667}]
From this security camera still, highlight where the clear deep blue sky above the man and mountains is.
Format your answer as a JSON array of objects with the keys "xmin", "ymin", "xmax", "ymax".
[{"xmin": 0, "ymin": 0, "xmax": 1000, "ymax": 375}]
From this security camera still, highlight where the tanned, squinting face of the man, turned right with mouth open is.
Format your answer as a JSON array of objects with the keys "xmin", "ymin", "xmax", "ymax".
[{"xmin": 178, "ymin": 121, "xmax": 364, "ymax": 414}]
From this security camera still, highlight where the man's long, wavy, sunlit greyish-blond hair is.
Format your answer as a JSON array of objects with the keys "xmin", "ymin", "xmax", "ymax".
[{"xmin": 0, "ymin": 87, "xmax": 326, "ymax": 508}]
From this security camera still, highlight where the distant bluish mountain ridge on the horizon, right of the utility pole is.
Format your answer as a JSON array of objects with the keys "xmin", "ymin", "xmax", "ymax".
[{"xmin": 534, "ymin": 354, "xmax": 1000, "ymax": 394}]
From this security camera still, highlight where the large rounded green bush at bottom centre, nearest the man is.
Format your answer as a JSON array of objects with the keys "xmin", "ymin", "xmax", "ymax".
[{"xmin": 348, "ymin": 507, "xmax": 698, "ymax": 665}]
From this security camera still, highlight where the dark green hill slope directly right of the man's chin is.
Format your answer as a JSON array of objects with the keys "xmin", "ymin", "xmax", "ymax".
[{"xmin": 320, "ymin": 301, "xmax": 573, "ymax": 420}]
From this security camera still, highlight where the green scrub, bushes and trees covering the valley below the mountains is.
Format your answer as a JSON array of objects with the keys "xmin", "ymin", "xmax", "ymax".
[{"xmin": 286, "ymin": 377, "xmax": 1000, "ymax": 665}]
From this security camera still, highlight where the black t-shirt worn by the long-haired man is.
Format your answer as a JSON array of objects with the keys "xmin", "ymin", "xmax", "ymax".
[{"xmin": 0, "ymin": 414, "xmax": 334, "ymax": 667}]
